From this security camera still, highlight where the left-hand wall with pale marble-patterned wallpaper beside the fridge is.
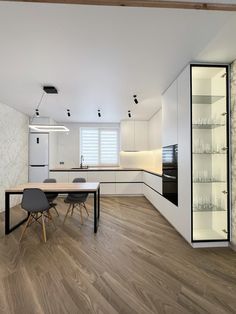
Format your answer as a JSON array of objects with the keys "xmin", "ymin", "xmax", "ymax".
[{"xmin": 0, "ymin": 104, "xmax": 29, "ymax": 211}]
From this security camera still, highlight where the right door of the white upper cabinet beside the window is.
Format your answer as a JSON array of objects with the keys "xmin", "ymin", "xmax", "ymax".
[{"xmin": 134, "ymin": 121, "xmax": 148, "ymax": 151}]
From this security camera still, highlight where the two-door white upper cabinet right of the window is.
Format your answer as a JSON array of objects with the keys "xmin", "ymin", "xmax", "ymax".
[{"xmin": 120, "ymin": 120, "xmax": 148, "ymax": 151}]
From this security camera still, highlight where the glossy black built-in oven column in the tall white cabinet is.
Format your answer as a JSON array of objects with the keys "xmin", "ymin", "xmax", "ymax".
[{"xmin": 162, "ymin": 144, "xmax": 178, "ymax": 206}]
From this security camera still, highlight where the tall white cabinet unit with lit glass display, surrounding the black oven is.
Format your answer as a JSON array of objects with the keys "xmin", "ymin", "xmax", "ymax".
[{"xmin": 158, "ymin": 64, "xmax": 230, "ymax": 247}]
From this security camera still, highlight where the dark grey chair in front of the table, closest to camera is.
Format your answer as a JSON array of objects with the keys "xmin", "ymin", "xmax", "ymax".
[{"xmin": 20, "ymin": 188, "xmax": 55, "ymax": 242}]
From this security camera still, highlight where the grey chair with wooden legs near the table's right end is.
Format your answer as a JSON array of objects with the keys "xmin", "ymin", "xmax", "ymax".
[{"xmin": 63, "ymin": 178, "xmax": 89, "ymax": 224}]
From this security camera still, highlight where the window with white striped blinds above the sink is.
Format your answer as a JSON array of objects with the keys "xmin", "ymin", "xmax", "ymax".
[{"xmin": 80, "ymin": 127, "xmax": 119, "ymax": 166}]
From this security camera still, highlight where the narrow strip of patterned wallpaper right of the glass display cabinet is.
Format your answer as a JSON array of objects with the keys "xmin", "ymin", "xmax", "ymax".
[{"xmin": 231, "ymin": 60, "xmax": 236, "ymax": 248}]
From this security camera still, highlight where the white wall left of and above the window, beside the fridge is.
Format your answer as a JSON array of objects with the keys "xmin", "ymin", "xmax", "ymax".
[{"xmin": 49, "ymin": 123, "xmax": 119, "ymax": 169}]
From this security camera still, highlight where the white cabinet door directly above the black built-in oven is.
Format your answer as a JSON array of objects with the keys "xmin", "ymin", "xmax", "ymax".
[{"xmin": 162, "ymin": 80, "xmax": 178, "ymax": 146}]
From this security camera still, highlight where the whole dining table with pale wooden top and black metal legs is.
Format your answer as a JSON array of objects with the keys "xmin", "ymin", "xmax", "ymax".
[{"xmin": 5, "ymin": 182, "xmax": 100, "ymax": 234}]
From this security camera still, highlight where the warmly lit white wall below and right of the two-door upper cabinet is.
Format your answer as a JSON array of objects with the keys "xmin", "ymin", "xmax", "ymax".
[{"xmin": 120, "ymin": 109, "xmax": 162, "ymax": 174}]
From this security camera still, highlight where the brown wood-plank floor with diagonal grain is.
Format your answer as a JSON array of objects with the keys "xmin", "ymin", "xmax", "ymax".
[{"xmin": 0, "ymin": 197, "xmax": 236, "ymax": 314}]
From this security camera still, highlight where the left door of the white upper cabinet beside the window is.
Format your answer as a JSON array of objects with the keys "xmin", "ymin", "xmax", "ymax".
[{"xmin": 120, "ymin": 120, "xmax": 135, "ymax": 151}]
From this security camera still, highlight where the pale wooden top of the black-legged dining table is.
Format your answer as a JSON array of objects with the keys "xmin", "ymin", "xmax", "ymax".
[{"xmin": 5, "ymin": 182, "xmax": 100, "ymax": 193}]
